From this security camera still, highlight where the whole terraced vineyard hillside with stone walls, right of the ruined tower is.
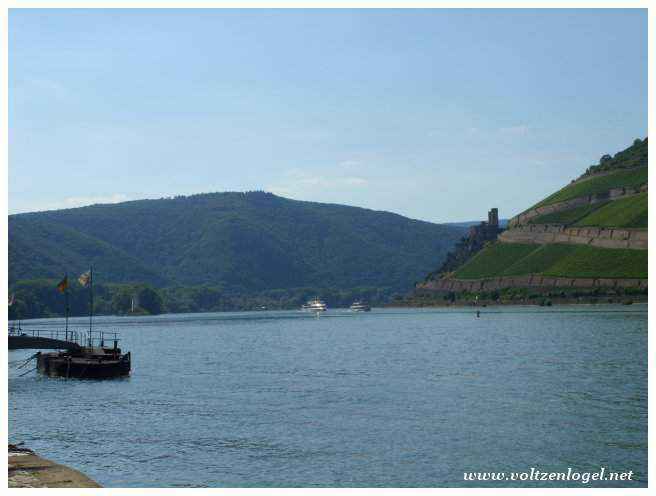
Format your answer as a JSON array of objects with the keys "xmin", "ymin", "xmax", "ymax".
[{"xmin": 418, "ymin": 139, "xmax": 648, "ymax": 292}]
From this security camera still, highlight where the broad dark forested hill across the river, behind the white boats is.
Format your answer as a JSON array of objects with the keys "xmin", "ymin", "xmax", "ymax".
[{"xmin": 9, "ymin": 192, "xmax": 465, "ymax": 293}]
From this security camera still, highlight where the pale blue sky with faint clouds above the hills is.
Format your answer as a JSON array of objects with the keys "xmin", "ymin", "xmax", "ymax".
[{"xmin": 9, "ymin": 9, "xmax": 647, "ymax": 222}]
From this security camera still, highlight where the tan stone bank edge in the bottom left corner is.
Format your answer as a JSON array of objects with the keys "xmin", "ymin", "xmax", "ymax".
[{"xmin": 7, "ymin": 444, "xmax": 102, "ymax": 488}]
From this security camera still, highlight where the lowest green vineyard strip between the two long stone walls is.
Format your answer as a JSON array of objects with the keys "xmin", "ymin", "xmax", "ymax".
[{"xmin": 455, "ymin": 243, "xmax": 647, "ymax": 279}]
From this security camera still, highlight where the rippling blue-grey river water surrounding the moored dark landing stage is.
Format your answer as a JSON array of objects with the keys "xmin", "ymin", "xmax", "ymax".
[{"xmin": 9, "ymin": 305, "xmax": 647, "ymax": 487}]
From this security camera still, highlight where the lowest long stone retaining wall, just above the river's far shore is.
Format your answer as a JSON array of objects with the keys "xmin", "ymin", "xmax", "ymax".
[{"xmin": 417, "ymin": 275, "xmax": 647, "ymax": 292}]
